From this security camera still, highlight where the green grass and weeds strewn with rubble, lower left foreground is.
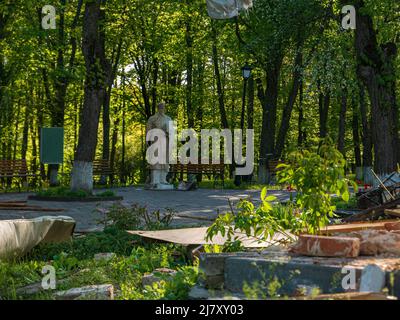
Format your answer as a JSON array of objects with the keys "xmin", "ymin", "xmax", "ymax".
[{"xmin": 0, "ymin": 227, "xmax": 198, "ymax": 300}]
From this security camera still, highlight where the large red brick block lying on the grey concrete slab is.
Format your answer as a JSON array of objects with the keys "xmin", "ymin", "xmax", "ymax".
[{"xmin": 290, "ymin": 235, "xmax": 360, "ymax": 257}]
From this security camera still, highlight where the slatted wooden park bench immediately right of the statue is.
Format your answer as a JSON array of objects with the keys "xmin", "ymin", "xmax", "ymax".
[{"xmin": 169, "ymin": 163, "xmax": 225, "ymax": 187}]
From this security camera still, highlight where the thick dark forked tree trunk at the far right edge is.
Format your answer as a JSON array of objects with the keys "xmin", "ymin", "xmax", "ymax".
[{"xmin": 355, "ymin": 0, "xmax": 399, "ymax": 175}]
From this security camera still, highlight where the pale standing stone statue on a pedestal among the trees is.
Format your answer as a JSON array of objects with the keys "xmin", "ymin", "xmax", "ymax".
[{"xmin": 146, "ymin": 102, "xmax": 174, "ymax": 190}]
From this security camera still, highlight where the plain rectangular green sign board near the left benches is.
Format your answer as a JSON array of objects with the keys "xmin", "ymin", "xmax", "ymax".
[{"xmin": 40, "ymin": 128, "xmax": 64, "ymax": 164}]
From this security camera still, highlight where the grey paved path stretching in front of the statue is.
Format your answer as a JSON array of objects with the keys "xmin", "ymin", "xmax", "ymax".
[{"xmin": 0, "ymin": 187, "xmax": 290, "ymax": 231}]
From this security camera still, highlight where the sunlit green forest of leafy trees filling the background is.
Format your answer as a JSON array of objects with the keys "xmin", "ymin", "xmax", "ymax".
[{"xmin": 0, "ymin": 0, "xmax": 400, "ymax": 189}]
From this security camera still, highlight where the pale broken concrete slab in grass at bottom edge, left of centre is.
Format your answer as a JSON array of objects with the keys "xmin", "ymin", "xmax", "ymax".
[{"xmin": 54, "ymin": 284, "xmax": 114, "ymax": 300}]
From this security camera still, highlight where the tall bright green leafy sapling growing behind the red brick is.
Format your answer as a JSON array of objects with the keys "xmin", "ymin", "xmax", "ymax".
[{"xmin": 278, "ymin": 140, "xmax": 357, "ymax": 234}]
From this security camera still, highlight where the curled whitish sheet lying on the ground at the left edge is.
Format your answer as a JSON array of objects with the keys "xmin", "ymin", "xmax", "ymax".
[{"xmin": 0, "ymin": 216, "xmax": 75, "ymax": 259}]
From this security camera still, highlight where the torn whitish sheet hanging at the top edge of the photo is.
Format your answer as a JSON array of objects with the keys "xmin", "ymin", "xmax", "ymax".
[{"xmin": 207, "ymin": 0, "xmax": 253, "ymax": 19}]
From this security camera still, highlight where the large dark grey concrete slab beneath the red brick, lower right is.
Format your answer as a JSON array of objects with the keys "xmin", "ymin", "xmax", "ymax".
[{"xmin": 206, "ymin": 251, "xmax": 400, "ymax": 297}]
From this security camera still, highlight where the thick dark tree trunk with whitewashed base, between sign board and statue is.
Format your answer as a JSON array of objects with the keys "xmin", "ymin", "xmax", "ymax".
[{"xmin": 71, "ymin": 0, "xmax": 106, "ymax": 193}]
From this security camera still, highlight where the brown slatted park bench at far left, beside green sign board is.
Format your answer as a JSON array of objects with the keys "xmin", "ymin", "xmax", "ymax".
[{"xmin": 0, "ymin": 159, "xmax": 37, "ymax": 191}]
